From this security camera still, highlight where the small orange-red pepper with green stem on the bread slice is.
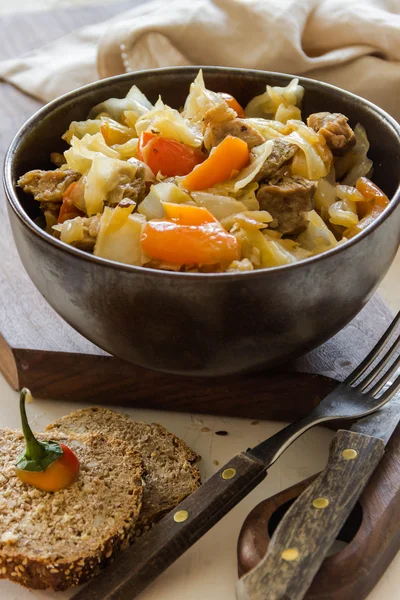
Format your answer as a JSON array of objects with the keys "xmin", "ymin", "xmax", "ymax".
[{"xmin": 16, "ymin": 388, "xmax": 79, "ymax": 492}]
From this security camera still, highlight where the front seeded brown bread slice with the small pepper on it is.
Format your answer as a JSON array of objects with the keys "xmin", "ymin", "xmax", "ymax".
[{"xmin": 0, "ymin": 429, "xmax": 143, "ymax": 590}]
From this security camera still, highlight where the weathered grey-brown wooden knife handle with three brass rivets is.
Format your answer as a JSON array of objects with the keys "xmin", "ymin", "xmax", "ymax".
[{"xmin": 237, "ymin": 430, "xmax": 385, "ymax": 600}]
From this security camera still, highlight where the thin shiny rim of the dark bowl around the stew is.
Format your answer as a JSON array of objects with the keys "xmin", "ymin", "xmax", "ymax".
[{"xmin": 3, "ymin": 65, "xmax": 400, "ymax": 280}]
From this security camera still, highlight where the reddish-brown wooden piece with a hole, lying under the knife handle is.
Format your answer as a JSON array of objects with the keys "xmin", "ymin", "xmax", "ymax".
[{"xmin": 238, "ymin": 425, "xmax": 400, "ymax": 600}]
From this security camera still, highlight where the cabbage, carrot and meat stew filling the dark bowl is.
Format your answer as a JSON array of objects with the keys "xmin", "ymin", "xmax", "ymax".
[{"xmin": 18, "ymin": 71, "xmax": 389, "ymax": 272}]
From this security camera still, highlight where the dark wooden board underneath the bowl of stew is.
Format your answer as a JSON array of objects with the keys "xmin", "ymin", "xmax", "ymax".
[{"xmin": 0, "ymin": 2, "xmax": 390, "ymax": 419}]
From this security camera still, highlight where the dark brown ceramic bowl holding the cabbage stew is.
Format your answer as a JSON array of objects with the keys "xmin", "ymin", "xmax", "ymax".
[{"xmin": 4, "ymin": 67, "xmax": 400, "ymax": 375}]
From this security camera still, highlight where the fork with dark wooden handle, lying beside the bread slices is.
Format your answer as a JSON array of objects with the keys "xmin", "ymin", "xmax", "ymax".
[{"xmin": 74, "ymin": 313, "xmax": 400, "ymax": 600}]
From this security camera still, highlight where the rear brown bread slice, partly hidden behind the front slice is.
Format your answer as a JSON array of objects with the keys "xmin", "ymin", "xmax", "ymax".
[{"xmin": 47, "ymin": 406, "xmax": 200, "ymax": 535}]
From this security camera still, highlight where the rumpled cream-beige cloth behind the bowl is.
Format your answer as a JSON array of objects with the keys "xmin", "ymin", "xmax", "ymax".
[{"xmin": 0, "ymin": 0, "xmax": 400, "ymax": 120}]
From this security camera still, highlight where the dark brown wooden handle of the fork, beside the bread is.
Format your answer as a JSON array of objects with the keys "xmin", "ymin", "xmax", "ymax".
[{"xmin": 73, "ymin": 452, "xmax": 267, "ymax": 600}]
